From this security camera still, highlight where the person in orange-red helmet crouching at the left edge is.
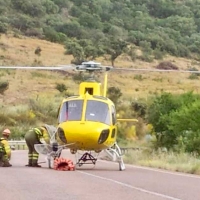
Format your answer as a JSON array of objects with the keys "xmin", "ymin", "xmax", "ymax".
[{"xmin": 0, "ymin": 129, "xmax": 12, "ymax": 167}]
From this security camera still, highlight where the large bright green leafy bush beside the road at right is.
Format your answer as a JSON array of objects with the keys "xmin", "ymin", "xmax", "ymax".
[{"xmin": 147, "ymin": 92, "xmax": 200, "ymax": 153}]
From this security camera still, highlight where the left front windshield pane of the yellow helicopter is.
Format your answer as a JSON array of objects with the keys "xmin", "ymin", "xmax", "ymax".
[{"xmin": 59, "ymin": 100, "xmax": 83, "ymax": 123}]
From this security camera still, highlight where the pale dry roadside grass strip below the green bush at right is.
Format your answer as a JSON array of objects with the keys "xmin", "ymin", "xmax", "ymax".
[{"xmin": 124, "ymin": 151, "xmax": 200, "ymax": 175}]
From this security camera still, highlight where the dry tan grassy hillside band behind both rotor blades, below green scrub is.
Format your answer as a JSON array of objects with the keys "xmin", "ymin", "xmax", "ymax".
[{"xmin": 0, "ymin": 35, "xmax": 200, "ymax": 104}]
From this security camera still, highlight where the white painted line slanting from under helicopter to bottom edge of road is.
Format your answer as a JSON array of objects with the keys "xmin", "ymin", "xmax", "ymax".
[{"xmin": 77, "ymin": 171, "xmax": 181, "ymax": 200}]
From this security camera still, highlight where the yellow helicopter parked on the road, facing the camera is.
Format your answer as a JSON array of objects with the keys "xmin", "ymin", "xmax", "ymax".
[{"xmin": 53, "ymin": 61, "xmax": 137, "ymax": 170}]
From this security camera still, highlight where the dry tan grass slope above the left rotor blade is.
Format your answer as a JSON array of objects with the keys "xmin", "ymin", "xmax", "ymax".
[{"xmin": 0, "ymin": 35, "xmax": 72, "ymax": 66}]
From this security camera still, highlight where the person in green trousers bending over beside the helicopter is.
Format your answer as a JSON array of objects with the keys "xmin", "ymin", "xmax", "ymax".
[{"xmin": 25, "ymin": 124, "xmax": 56, "ymax": 167}]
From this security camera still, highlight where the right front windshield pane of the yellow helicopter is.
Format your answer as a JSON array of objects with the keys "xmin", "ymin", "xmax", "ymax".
[{"xmin": 85, "ymin": 100, "xmax": 110, "ymax": 125}]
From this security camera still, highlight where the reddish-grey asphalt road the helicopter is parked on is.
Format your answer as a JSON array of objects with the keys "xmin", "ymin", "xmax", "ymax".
[{"xmin": 0, "ymin": 150, "xmax": 200, "ymax": 200}]
